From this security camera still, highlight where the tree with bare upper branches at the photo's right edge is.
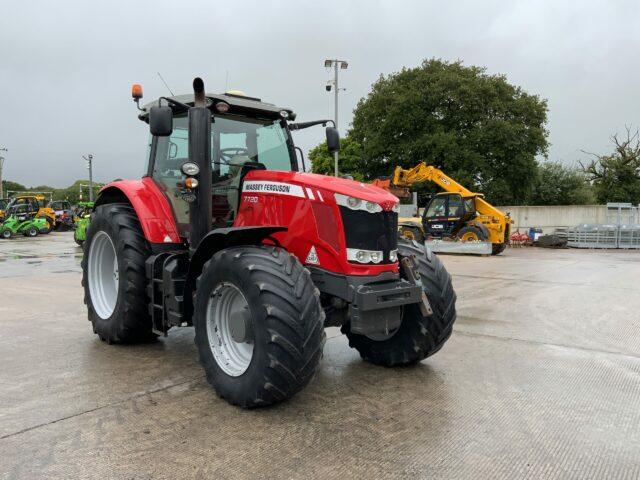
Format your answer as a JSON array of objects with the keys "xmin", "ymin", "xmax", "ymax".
[{"xmin": 581, "ymin": 127, "xmax": 640, "ymax": 204}]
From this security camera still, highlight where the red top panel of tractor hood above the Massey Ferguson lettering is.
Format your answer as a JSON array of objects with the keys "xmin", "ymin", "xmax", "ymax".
[{"xmin": 243, "ymin": 170, "xmax": 399, "ymax": 210}]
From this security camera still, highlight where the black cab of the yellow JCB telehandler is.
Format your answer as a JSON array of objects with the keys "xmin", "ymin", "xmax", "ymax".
[{"xmin": 422, "ymin": 192, "xmax": 477, "ymax": 238}]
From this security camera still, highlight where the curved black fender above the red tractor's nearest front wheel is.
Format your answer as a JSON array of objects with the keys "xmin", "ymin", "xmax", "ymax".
[{"xmin": 183, "ymin": 226, "xmax": 287, "ymax": 321}]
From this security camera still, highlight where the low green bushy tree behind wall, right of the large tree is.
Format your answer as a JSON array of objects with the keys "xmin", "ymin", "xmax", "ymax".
[{"xmin": 530, "ymin": 162, "xmax": 596, "ymax": 205}]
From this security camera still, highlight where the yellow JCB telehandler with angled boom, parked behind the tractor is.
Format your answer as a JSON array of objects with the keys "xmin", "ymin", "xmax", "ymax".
[{"xmin": 382, "ymin": 162, "xmax": 513, "ymax": 255}]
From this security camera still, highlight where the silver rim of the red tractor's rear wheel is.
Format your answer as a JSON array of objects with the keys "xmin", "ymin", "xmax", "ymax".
[{"xmin": 87, "ymin": 230, "xmax": 119, "ymax": 319}]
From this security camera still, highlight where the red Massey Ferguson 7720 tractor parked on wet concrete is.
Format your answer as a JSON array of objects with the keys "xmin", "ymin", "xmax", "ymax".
[{"xmin": 82, "ymin": 78, "xmax": 456, "ymax": 407}]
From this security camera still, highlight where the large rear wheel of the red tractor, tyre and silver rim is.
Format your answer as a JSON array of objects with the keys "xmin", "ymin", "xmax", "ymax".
[{"xmin": 82, "ymin": 203, "xmax": 154, "ymax": 343}]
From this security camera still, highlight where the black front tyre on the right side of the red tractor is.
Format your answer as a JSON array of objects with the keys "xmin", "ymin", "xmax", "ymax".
[{"xmin": 342, "ymin": 239, "xmax": 456, "ymax": 367}]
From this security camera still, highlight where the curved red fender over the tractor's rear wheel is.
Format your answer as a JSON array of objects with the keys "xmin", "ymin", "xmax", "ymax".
[{"xmin": 94, "ymin": 177, "xmax": 182, "ymax": 244}]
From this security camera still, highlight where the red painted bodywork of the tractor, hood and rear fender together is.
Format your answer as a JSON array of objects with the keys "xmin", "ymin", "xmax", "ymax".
[{"xmin": 103, "ymin": 170, "xmax": 398, "ymax": 275}]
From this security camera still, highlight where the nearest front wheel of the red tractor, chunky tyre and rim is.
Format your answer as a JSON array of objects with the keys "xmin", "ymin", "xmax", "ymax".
[{"xmin": 193, "ymin": 246, "xmax": 325, "ymax": 408}]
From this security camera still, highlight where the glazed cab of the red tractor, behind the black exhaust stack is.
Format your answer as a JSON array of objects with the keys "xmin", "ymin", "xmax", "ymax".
[{"xmin": 145, "ymin": 94, "xmax": 300, "ymax": 233}]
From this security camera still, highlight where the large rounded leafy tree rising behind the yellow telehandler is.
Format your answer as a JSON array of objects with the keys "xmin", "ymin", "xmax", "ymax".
[{"xmin": 350, "ymin": 59, "xmax": 548, "ymax": 204}]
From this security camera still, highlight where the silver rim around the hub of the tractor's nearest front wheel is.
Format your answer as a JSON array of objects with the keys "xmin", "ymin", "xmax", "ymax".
[{"xmin": 206, "ymin": 282, "xmax": 253, "ymax": 377}]
